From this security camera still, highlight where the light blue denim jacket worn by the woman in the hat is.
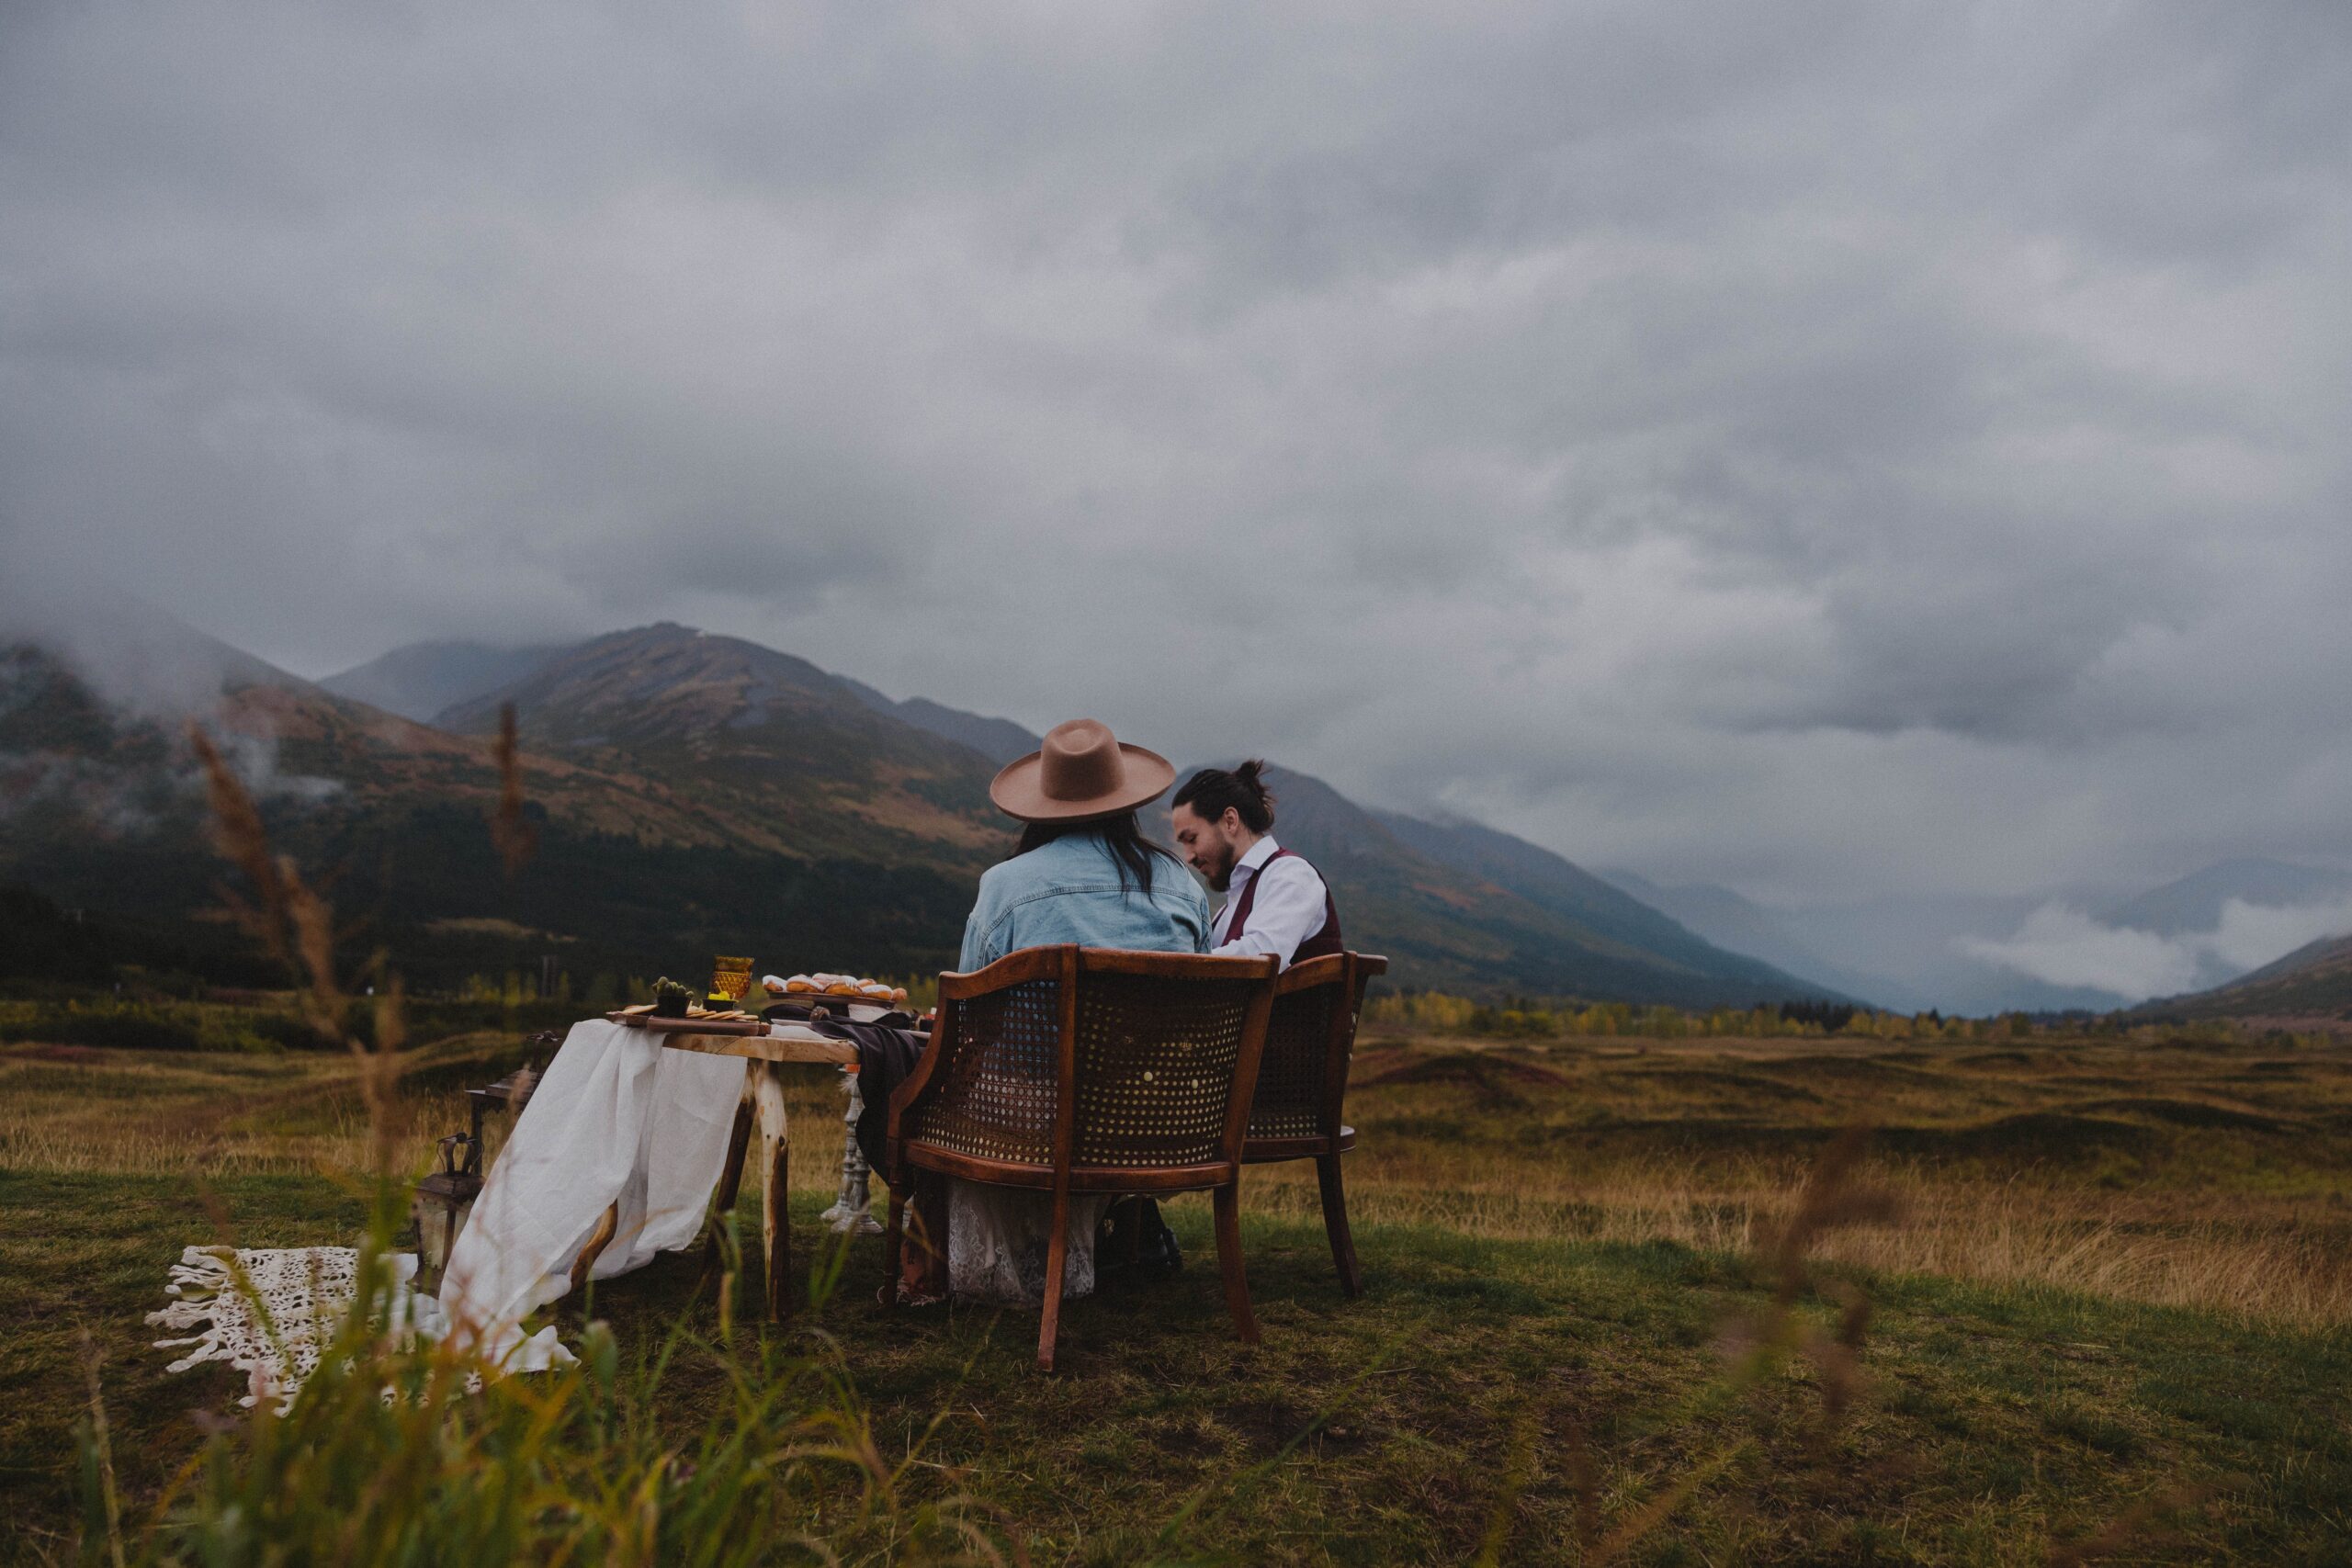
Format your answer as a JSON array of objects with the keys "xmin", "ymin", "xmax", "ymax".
[{"xmin": 959, "ymin": 832, "xmax": 1209, "ymax": 971}]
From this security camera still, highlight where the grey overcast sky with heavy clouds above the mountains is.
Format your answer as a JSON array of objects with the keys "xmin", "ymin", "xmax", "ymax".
[{"xmin": 0, "ymin": 0, "xmax": 2352, "ymax": 900}]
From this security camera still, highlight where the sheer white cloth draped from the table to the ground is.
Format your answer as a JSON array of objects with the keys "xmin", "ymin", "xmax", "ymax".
[{"xmin": 440, "ymin": 1018, "xmax": 743, "ymax": 1361}]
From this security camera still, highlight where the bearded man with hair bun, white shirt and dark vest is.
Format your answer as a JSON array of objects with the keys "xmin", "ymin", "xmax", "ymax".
[{"xmin": 1169, "ymin": 761, "xmax": 1348, "ymax": 968}]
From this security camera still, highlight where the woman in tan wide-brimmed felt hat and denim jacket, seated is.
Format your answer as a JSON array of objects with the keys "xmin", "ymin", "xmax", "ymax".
[{"xmin": 879, "ymin": 719, "xmax": 1209, "ymax": 1304}]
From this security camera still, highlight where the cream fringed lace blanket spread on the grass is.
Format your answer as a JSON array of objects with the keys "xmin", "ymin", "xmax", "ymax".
[{"xmin": 146, "ymin": 1246, "xmax": 571, "ymax": 1411}]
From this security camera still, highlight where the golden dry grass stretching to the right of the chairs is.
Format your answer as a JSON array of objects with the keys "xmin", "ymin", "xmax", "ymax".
[{"xmin": 1279, "ymin": 1037, "xmax": 2352, "ymax": 1325}]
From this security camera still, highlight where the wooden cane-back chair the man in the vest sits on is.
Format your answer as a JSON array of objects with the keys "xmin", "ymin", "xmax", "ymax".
[{"xmin": 1242, "ymin": 952, "xmax": 1387, "ymax": 1295}]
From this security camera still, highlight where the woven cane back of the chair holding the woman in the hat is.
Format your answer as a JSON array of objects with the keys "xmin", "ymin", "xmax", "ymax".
[{"xmin": 894, "ymin": 945, "xmax": 1275, "ymax": 1173}]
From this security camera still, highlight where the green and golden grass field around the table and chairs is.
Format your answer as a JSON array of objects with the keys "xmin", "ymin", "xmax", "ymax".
[{"xmin": 0, "ymin": 1034, "xmax": 2352, "ymax": 1563}]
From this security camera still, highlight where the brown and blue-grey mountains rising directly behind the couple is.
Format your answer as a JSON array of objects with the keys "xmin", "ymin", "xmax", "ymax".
[{"xmin": 0, "ymin": 623, "xmax": 1835, "ymax": 1006}]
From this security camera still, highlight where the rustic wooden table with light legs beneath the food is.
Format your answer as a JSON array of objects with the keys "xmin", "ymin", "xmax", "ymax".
[{"xmin": 571, "ymin": 1010, "xmax": 858, "ymax": 1321}]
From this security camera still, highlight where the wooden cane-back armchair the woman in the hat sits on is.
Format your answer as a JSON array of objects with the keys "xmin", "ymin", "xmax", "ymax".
[{"xmin": 882, "ymin": 945, "xmax": 1275, "ymax": 1371}]
